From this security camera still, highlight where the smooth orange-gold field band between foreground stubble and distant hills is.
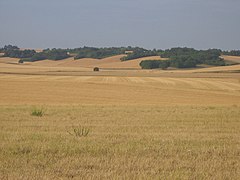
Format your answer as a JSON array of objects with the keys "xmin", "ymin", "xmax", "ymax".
[{"xmin": 0, "ymin": 75, "xmax": 240, "ymax": 105}]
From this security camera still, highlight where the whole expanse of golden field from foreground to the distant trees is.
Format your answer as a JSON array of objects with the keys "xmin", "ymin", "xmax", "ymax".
[{"xmin": 0, "ymin": 56, "xmax": 240, "ymax": 180}]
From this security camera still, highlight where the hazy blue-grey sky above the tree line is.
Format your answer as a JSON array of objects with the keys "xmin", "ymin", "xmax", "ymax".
[{"xmin": 0, "ymin": 0, "xmax": 240, "ymax": 49}]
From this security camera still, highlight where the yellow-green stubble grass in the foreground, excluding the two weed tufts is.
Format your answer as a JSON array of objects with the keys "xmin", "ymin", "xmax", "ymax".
[{"xmin": 0, "ymin": 105, "xmax": 240, "ymax": 179}]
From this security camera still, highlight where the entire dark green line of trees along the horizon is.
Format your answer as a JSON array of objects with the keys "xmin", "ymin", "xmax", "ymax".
[{"xmin": 0, "ymin": 45, "xmax": 240, "ymax": 69}]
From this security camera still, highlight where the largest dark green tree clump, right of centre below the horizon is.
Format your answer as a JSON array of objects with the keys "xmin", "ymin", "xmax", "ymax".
[{"xmin": 140, "ymin": 48, "xmax": 226, "ymax": 69}]
